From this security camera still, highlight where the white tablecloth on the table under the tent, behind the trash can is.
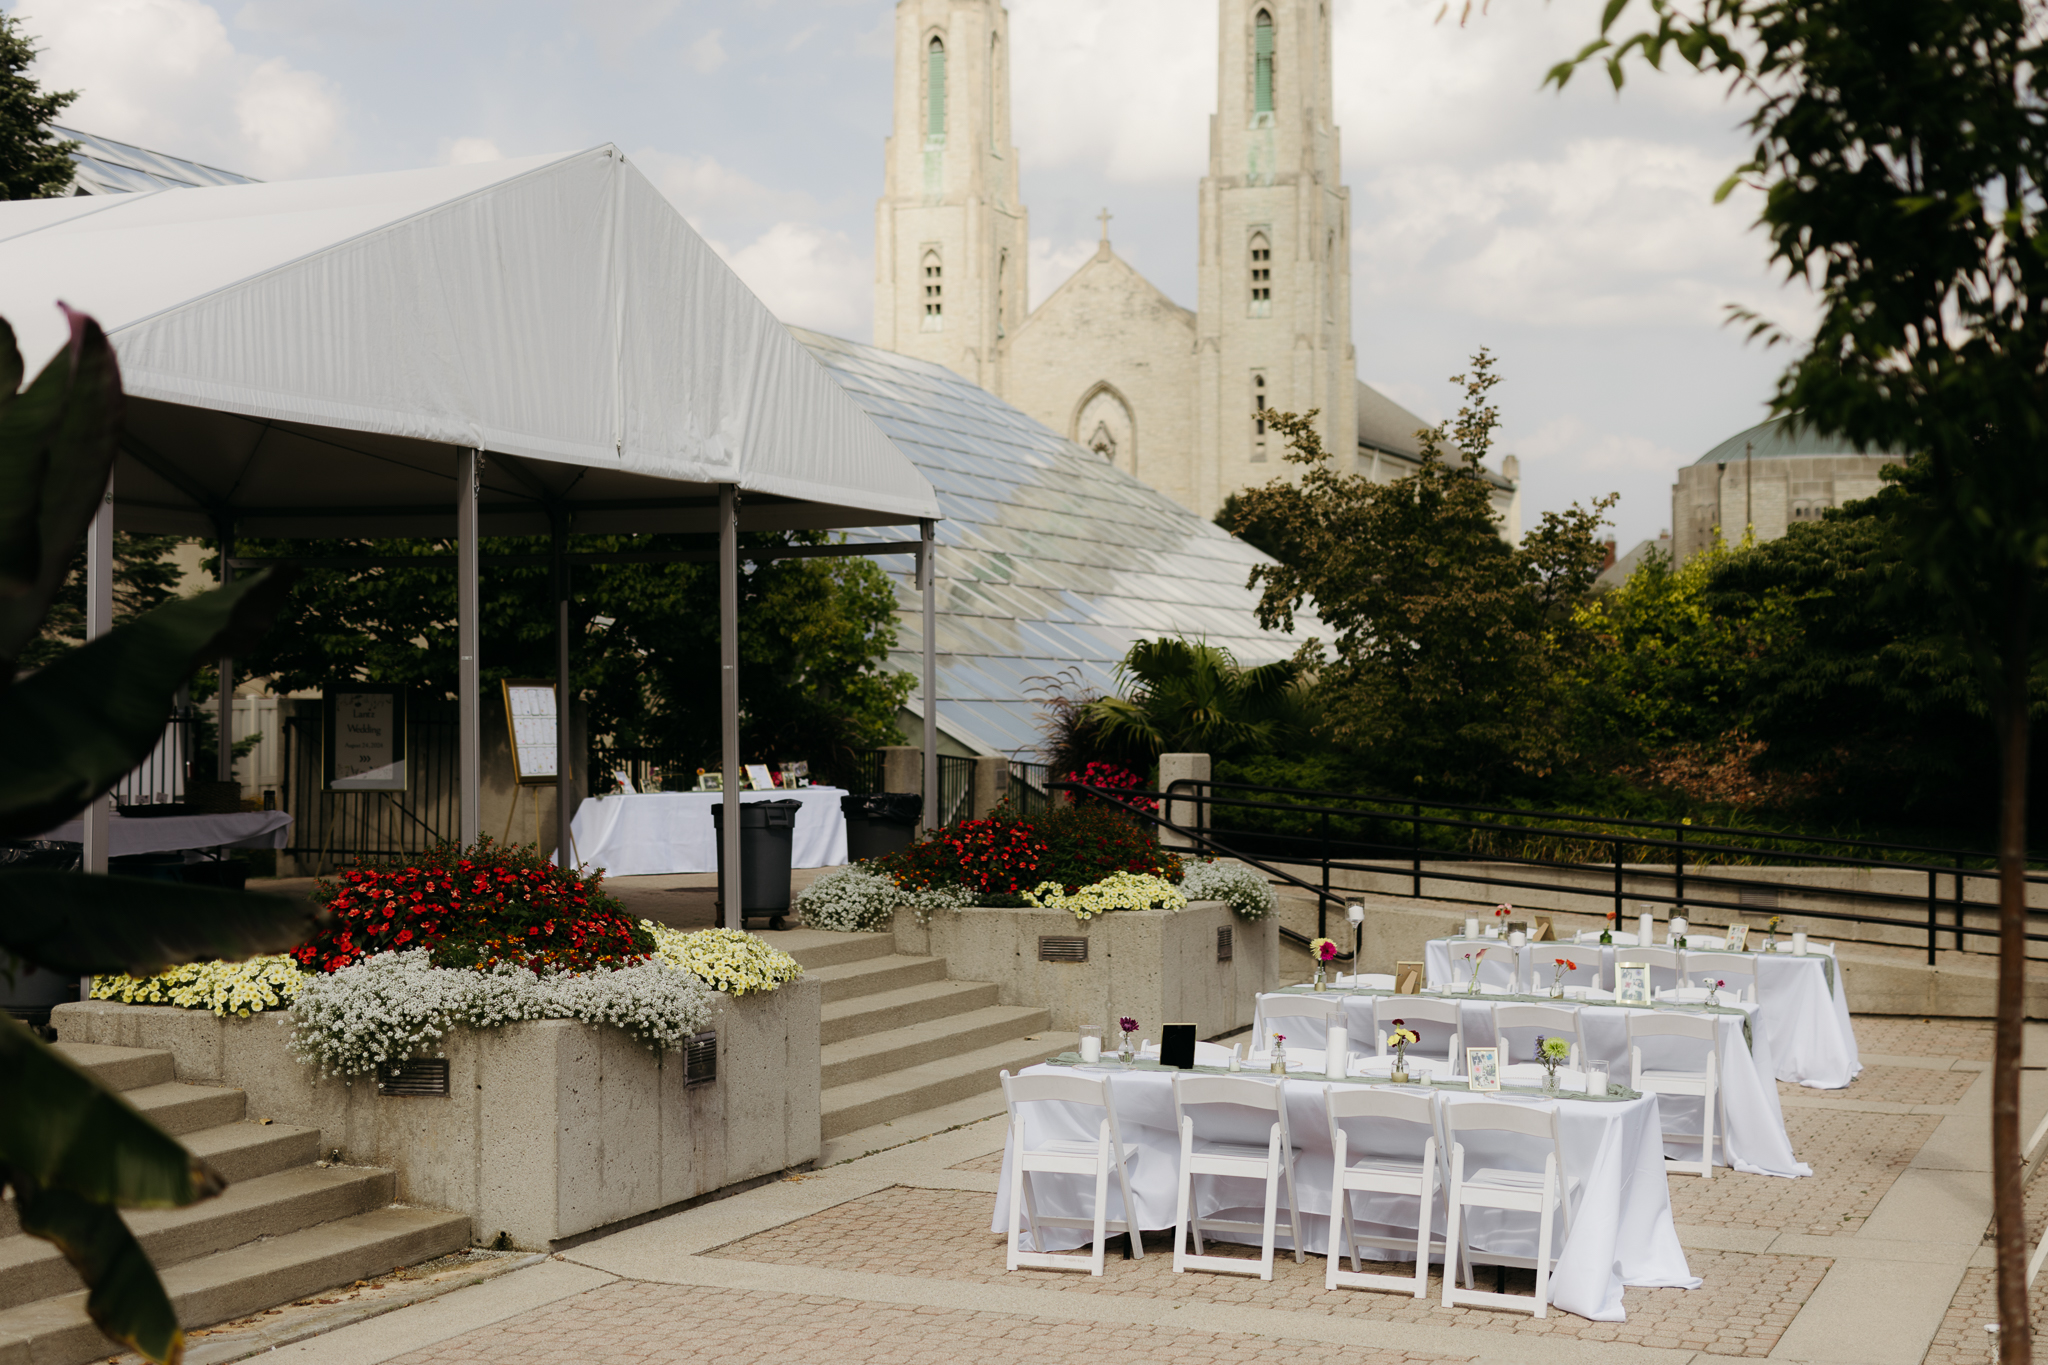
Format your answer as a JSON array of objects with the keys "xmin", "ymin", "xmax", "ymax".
[{"xmin": 569, "ymin": 786, "xmax": 846, "ymax": 876}]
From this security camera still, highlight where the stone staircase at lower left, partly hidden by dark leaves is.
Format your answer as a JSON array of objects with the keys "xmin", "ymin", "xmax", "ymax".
[{"xmin": 0, "ymin": 1044, "xmax": 469, "ymax": 1365}]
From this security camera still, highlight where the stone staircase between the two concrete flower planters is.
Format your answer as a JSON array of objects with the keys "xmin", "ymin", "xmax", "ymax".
[{"xmin": 768, "ymin": 929, "xmax": 1077, "ymax": 1142}]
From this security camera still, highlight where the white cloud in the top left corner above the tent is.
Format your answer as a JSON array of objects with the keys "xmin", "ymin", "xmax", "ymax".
[{"xmin": 14, "ymin": 0, "xmax": 342, "ymax": 176}]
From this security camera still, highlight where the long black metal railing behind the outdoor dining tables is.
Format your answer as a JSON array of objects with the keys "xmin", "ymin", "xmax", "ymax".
[{"xmin": 1049, "ymin": 780, "xmax": 2048, "ymax": 966}]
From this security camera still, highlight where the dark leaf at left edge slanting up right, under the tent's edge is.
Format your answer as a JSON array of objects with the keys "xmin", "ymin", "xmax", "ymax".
[{"xmin": 0, "ymin": 571, "xmax": 289, "ymax": 839}]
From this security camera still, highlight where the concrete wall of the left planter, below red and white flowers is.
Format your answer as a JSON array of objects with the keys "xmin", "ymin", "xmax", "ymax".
[{"xmin": 53, "ymin": 980, "xmax": 821, "ymax": 1248}]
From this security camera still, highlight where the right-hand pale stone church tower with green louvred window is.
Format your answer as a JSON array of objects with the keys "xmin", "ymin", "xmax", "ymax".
[{"xmin": 1194, "ymin": 0, "xmax": 1358, "ymax": 516}]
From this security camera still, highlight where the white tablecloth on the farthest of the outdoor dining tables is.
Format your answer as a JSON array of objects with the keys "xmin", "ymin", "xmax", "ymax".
[{"xmin": 1423, "ymin": 933, "xmax": 1864, "ymax": 1091}]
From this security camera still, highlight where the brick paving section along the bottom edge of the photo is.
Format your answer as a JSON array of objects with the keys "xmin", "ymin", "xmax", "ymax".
[{"xmin": 385, "ymin": 1281, "xmax": 1473, "ymax": 1365}]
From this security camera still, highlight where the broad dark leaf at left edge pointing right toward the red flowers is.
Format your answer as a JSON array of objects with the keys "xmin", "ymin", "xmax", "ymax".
[{"xmin": 0, "ymin": 870, "xmax": 319, "ymax": 976}]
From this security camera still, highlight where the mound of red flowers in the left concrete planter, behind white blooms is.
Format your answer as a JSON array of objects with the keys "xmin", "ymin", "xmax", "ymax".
[{"xmin": 291, "ymin": 839, "xmax": 653, "ymax": 972}]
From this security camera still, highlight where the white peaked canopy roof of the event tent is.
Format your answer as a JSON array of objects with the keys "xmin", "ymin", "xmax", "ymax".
[{"xmin": 0, "ymin": 147, "xmax": 938, "ymax": 534}]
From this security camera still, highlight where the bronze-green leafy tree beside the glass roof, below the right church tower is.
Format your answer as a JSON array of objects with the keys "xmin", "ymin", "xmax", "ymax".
[{"xmin": 1239, "ymin": 350, "xmax": 1614, "ymax": 794}]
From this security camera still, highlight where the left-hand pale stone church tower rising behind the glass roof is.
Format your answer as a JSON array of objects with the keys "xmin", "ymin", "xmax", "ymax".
[{"xmin": 874, "ymin": 0, "xmax": 1030, "ymax": 395}]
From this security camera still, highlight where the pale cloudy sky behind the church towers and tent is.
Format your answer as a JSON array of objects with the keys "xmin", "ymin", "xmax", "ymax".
[{"xmin": 12, "ymin": 0, "xmax": 1808, "ymax": 546}]
